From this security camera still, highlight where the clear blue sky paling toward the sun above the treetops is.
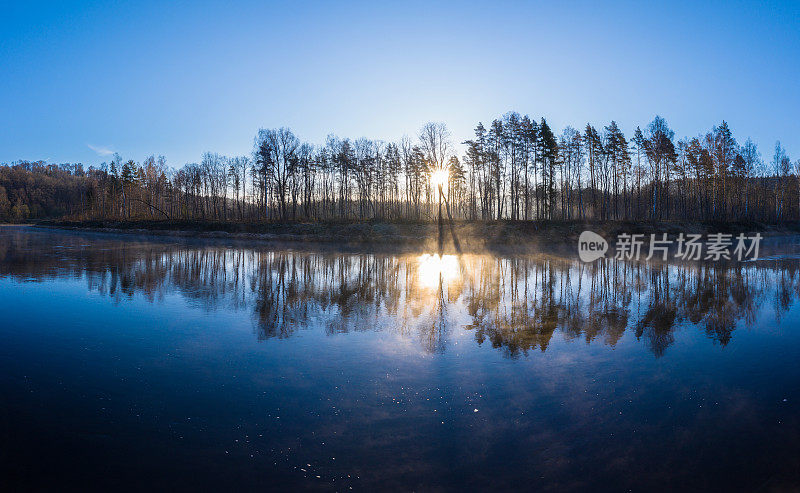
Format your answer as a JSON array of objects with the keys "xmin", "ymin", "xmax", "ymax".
[{"xmin": 0, "ymin": 0, "xmax": 800, "ymax": 167}]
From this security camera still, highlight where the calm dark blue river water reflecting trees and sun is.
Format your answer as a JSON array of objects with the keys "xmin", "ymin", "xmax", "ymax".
[{"xmin": 0, "ymin": 227, "xmax": 800, "ymax": 491}]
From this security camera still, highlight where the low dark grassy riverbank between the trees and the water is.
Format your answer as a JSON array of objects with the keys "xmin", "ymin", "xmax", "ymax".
[{"xmin": 36, "ymin": 220, "xmax": 800, "ymax": 251}]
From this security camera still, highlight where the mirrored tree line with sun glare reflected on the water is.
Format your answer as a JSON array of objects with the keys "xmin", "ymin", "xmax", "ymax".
[{"xmin": 0, "ymin": 232, "xmax": 800, "ymax": 357}]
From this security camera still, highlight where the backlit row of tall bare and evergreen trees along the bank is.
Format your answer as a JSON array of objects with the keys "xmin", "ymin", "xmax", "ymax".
[{"xmin": 0, "ymin": 112, "xmax": 800, "ymax": 223}]
